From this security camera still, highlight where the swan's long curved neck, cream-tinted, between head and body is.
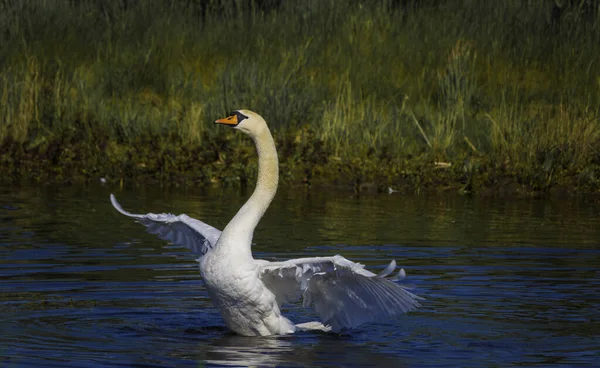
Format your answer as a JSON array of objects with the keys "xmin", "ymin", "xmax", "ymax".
[{"xmin": 219, "ymin": 126, "xmax": 279, "ymax": 257}]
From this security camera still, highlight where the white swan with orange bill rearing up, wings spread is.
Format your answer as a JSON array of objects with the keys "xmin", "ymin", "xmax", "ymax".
[{"xmin": 110, "ymin": 110, "xmax": 421, "ymax": 336}]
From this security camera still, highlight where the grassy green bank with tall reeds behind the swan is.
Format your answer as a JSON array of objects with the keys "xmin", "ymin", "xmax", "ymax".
[{"xmin": 0, "ymin": 0, "xmax": 600, "ymax": 192}]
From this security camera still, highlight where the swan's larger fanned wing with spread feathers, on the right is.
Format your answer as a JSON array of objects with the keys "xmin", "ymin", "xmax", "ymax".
[{"xmin": 257, "ymin": 255, "xmax": 422, "ymax": 332}]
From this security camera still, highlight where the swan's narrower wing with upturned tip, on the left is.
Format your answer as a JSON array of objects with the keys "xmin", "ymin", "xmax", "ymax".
[{"xmin": 110, "ymin": 194, "xmax": 221, "ymax": 256}]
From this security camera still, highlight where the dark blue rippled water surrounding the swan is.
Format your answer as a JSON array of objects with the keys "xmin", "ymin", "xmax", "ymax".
[{"xmin": 0, "ymin": 187, "xmax": 600, "ymax": 367}]
